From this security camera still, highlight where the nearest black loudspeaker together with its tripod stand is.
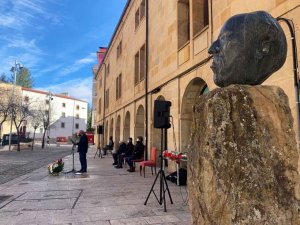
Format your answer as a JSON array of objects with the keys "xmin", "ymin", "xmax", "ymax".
[{"xmin": 144, "ymin": 100, "xmax": 173, "ymax": 212}]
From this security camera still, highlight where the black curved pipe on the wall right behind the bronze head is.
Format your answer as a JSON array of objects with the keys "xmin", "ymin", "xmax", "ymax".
[{"xmin": 277, "ymin": 17, "xmax": 300, "ymax": 151}]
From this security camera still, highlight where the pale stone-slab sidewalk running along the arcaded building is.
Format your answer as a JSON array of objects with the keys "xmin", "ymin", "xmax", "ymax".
[{"xmin": 0, "ymin": 147, "xmax": 191, "ymax": 225}]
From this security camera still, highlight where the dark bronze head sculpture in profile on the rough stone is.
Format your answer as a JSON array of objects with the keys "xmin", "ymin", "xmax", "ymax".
[{"xmin": 208, "ymin": 11, "xmax": 287, "ymax": 87}]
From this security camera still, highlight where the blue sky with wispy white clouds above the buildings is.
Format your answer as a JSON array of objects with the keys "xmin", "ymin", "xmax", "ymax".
[{"xmin": 0, "ymin": 0, "xmax": 127, "ymax": 103}]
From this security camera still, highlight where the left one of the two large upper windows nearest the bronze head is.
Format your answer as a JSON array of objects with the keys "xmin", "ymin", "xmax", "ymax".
[{"xmin": 177, "ymin": 0, "xmax": 190, "ymax": 48}]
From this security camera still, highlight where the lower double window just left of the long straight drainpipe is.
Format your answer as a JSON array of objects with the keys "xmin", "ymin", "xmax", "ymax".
[{"xmin": 134, "ymin": 44, "xmax": 146, "ymax": 84}]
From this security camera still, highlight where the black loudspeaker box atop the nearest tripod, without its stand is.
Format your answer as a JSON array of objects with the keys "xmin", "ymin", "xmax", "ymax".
[{"xmin": 154, "ymin": 100, "xmax": 172, "ymax": 128}]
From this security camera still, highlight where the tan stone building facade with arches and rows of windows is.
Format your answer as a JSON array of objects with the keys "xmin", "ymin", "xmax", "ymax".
[{"xmin": 94, "ymin": 0, "xmax": 300, "ymax": 163}]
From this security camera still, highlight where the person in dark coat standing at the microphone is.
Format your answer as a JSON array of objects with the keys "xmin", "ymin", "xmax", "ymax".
[{"xmin": 76, "ymin": 130, "xmax": 89, "ymax": 173}]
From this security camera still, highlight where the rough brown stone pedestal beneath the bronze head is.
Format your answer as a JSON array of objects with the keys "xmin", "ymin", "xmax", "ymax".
[{"xmin": 188, "ymin": 85, "xmax": 300, "ymax": 225}]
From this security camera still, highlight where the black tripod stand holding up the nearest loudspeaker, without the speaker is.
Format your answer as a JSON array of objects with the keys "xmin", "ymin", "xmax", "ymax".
[{"xmin": 144, "ymin": 128, "xmax": 173, "ymax": 212}]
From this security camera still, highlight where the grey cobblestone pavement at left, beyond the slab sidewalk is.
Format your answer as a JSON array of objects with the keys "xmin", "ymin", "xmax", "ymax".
[{"xmin": 0, "ymin": 146, "xmax": 71, "ymax": 184}]
